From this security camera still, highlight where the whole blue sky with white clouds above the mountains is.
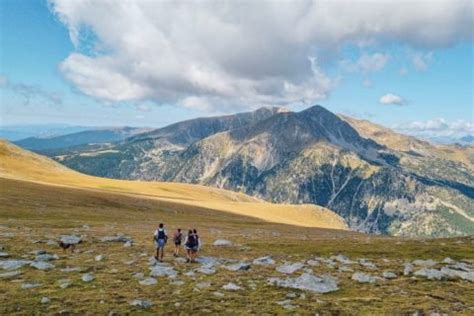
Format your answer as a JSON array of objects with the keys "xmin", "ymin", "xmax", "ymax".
[{"xmin": 0, "ymin": 0, "xmax": 474, "ymax": 136}]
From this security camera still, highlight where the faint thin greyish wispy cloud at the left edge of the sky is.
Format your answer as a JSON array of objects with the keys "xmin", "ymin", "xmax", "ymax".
[{"xmin": 0, "ymin": 76, "xmax": 63, "ymax": 106}]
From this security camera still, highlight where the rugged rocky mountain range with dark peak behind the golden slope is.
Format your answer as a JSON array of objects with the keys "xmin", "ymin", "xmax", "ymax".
[{"xmin": 19, "ymin": 106, "xmax": 474, "ymax": 236}]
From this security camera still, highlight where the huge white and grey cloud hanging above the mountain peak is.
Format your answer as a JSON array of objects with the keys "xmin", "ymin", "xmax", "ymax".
[{"xmin": 50, "ymin": 0, "xmax": 473, "ymax": 111}]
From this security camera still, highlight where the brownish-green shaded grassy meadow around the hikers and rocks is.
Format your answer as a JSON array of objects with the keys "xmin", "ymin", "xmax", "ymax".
[{"xmin": 0, "ymin": 178, "xmax": 474, "ymax": 315}]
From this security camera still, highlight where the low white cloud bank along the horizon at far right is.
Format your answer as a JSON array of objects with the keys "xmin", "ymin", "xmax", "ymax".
[{"xmin": 394, "ymin": 118, "xmax": 474, "ymax": 138}]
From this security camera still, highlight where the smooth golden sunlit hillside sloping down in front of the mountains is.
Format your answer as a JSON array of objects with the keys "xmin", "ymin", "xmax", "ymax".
[{"xmin": 0, "ymin": 141, "xmax": 346, "ymax": 229}]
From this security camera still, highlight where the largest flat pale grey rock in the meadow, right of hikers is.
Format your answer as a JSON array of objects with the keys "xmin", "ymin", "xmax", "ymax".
[{"xmin": 268, "ymin": 273, "xmax": 339, "ymax": 293}]
